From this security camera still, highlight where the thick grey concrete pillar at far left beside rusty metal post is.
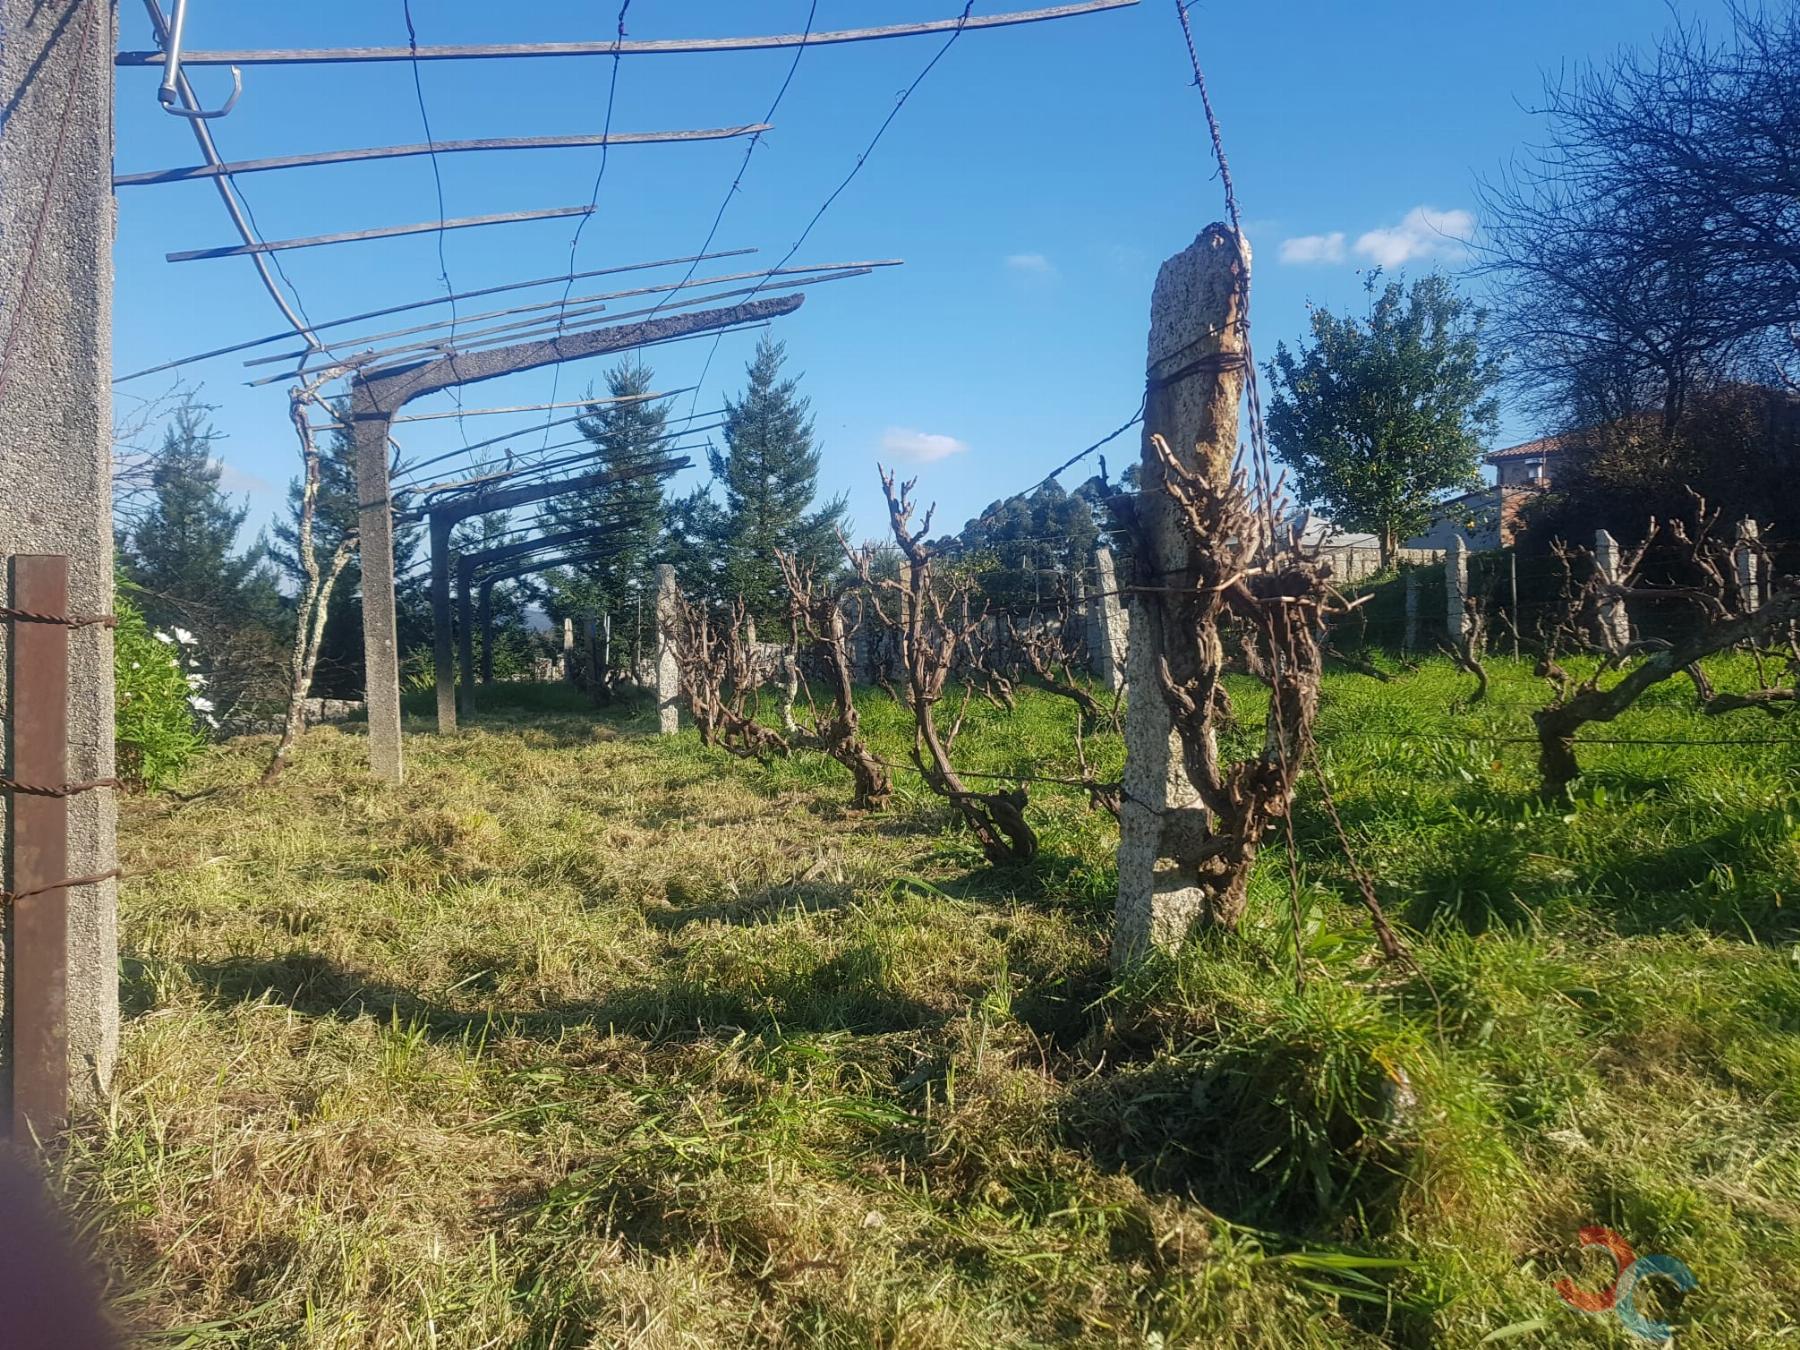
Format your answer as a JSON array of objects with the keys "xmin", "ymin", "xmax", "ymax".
[{"xmin": 0, "ymin": 0, "xmax": 122, "ymax": 1118}]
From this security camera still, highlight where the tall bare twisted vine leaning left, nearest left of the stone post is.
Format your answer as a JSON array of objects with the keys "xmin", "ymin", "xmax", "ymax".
[{"xmin": 844, "ymin": 468, "xmax": 1037, "ymax": 862}]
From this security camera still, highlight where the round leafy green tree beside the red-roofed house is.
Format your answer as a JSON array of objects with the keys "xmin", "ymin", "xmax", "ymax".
[{"xmin": 1269, "ymin": 272, "xmax": 1501, "ymax": 563}]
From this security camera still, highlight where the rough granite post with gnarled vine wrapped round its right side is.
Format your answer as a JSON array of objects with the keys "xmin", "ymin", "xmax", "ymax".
[{"xmin": 1112, "ymin": 225, "xmax": 1249, "ymax": 965}]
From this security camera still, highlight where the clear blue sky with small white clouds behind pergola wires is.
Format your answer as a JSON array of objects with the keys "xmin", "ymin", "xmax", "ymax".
[{"xmin": 105, "ymin": 0, "xmax": 1723, "ymax": 550}]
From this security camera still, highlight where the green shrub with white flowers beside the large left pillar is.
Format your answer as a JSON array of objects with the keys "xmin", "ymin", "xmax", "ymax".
[{"xmin": 113, "ymin": 596, "xmax": 212, "ymax": 788}]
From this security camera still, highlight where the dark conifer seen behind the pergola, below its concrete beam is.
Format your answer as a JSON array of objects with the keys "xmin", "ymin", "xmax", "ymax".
[{"xmin": 540, "ymin": 360, "xmax": 668, "ymax": 619}]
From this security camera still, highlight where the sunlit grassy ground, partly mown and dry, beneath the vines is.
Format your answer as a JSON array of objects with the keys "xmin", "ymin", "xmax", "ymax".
[{"xmin": 59, "ymin": 662, "xmax": 1800, "ymax": 1350}]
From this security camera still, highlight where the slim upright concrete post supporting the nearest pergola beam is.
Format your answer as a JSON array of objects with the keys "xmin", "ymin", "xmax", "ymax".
[{"xmin": 349, "ymin": 380, "xmax": 405, "ymax": 783}]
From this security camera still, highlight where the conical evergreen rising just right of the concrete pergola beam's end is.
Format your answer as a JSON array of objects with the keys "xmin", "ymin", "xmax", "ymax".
[{"xmin": 709, "ymin": 337, "xmax": 844, "ymax": 621}]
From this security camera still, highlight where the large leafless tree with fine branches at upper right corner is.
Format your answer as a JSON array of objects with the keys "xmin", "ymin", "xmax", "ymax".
[{"xmin": 1481, "ymin": 4, "xmax": 1800, "ymax": 432}]
